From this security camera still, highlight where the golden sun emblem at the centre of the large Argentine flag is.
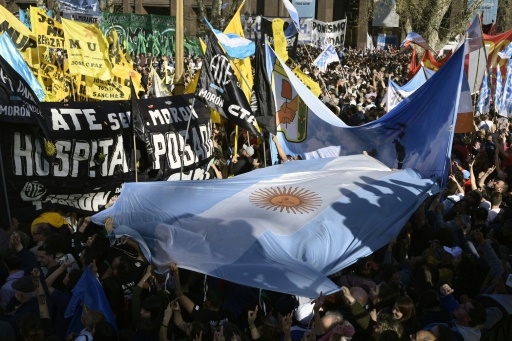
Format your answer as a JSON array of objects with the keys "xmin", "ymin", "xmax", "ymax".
[{"xmin": 249, "ymin": 187, "xmax": 322, "ymax": 214}]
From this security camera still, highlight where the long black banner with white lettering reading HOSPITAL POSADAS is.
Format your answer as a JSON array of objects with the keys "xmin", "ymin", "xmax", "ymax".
[{"xmin": 1, "ymin": 95, "xmax": 213, "ymax": 214}]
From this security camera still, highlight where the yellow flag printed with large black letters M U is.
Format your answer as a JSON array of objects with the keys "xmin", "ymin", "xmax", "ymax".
[{"xmin": 62, "ymin": 18, "xmax": 112, "ymax": 80}]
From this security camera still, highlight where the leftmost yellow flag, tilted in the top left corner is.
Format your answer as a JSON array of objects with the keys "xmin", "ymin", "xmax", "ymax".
[{"xmin": 0, "ymin": 5, "xmax": 39, "ymax": 69}]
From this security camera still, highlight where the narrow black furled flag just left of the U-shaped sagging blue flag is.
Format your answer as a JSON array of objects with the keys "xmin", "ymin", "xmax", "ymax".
[{"xmin": 253, "ymin": 41, "xmax": 276, "ymax": 135}]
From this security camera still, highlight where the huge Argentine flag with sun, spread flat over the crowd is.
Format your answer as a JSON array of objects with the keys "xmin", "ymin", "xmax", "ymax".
[{"xmin": 93, "ymin": 155, "xmax": 433, "ymax": 297}]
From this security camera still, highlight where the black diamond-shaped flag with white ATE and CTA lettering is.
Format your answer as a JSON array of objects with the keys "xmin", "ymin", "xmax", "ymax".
[{"xmin": 196, "ymin": 34, "xmax": 260, "ymax": 135}]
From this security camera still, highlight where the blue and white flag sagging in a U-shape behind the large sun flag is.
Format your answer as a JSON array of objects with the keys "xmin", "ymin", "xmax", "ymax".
[{"xmin": 267, "ymin": 41, "xmax": 465, "ymax": 184}]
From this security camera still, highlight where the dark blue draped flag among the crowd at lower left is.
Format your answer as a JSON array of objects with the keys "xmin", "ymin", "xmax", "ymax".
[{"xmin": 64, "ymin": 265, "xmax": 117, "ymax": 335}]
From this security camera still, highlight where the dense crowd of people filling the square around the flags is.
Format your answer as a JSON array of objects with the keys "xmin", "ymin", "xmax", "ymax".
[{"xmin": 0, "ymin": 44, "xmax": 512, "ymax": 341}]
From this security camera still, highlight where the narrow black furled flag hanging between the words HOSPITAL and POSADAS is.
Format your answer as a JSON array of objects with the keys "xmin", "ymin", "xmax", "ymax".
[{"xmin": 130, "ymin": 82, "xmax": 156, "ymax": 171}]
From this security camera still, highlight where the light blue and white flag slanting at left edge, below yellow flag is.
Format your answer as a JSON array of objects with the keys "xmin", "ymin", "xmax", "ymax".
[{"xmin": 0, "ymin": 34, "xmax": 46, "ymax": 101}]
